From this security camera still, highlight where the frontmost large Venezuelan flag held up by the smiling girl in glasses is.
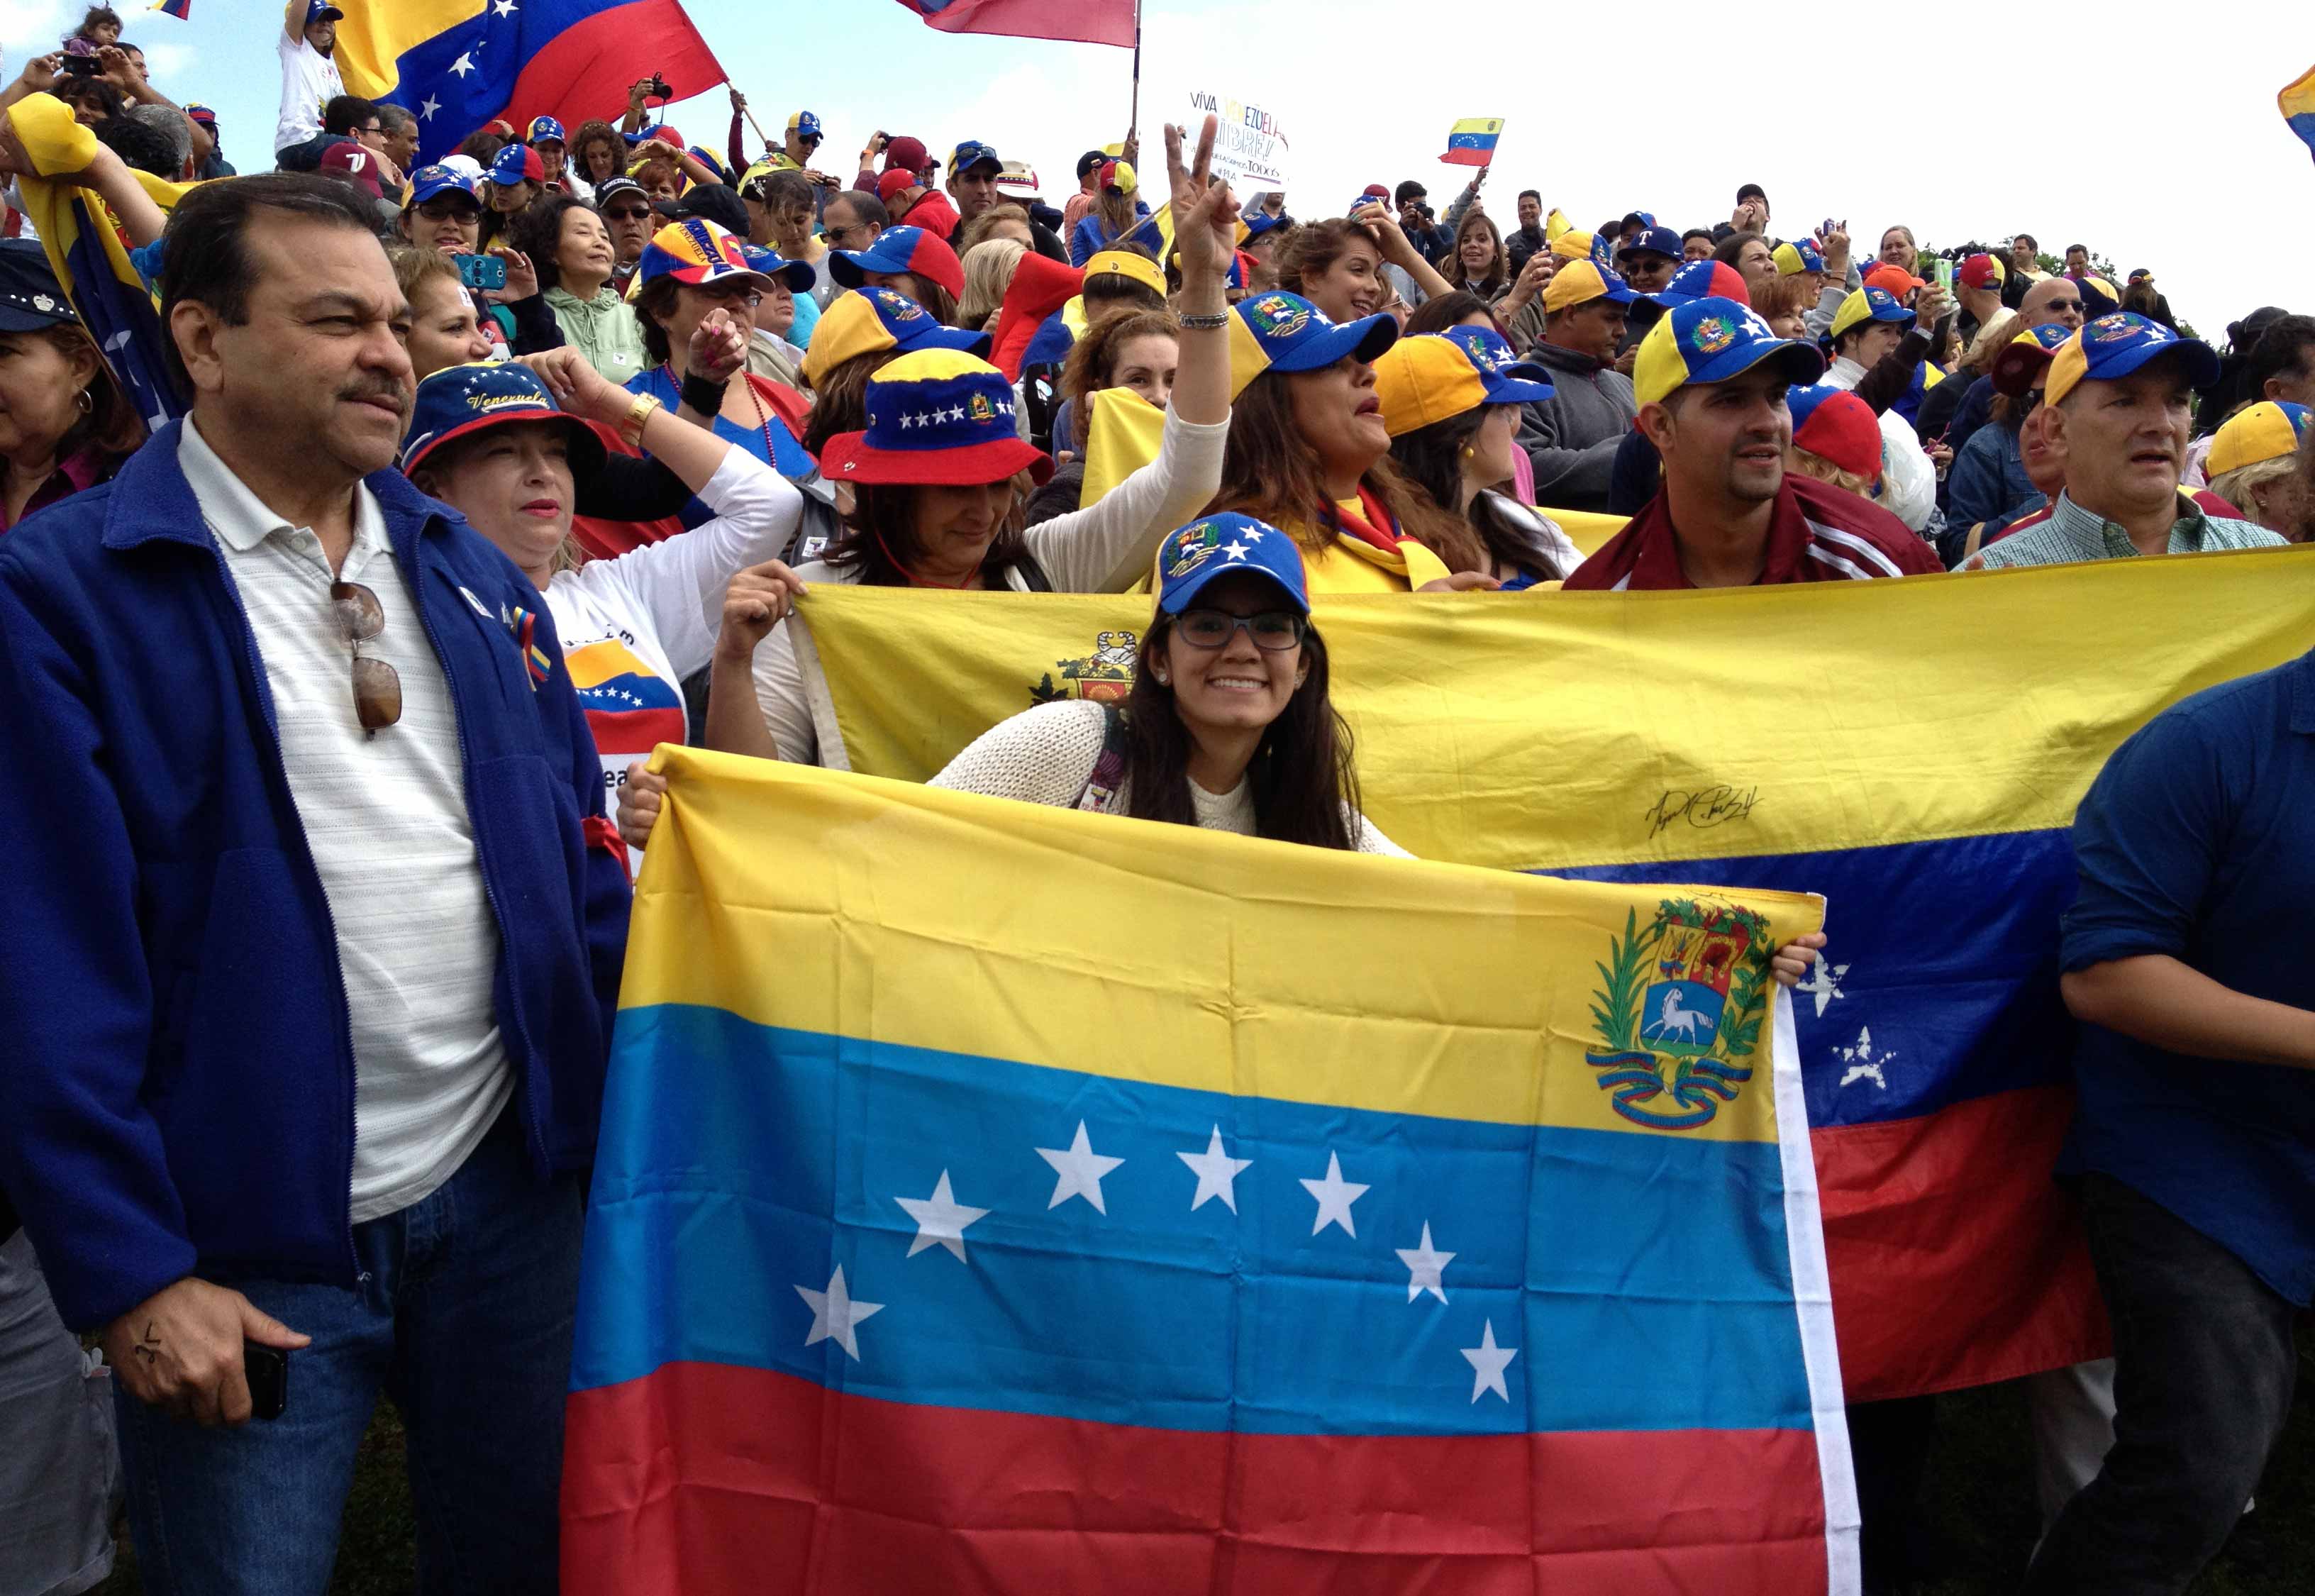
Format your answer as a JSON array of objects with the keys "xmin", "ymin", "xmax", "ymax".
[{"xmin": 562, "ymin": 750, "xmax": 1857, "ymax": 1596}]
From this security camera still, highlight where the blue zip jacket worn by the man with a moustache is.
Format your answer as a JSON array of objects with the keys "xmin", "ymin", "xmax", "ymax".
[{"xmin": 0, "ymin": 421, "xmax": 628, "ymax": 1329}]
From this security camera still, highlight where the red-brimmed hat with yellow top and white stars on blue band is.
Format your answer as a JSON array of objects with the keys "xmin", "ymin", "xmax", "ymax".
[{"xmin": 819, "ymin": 350, "xmax": 1053, "ymax": 487}]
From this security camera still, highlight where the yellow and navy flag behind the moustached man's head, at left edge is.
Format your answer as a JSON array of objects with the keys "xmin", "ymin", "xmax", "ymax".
[{"xmin": 9, "ymin": 95, "xmax": 185, "ymax": 426}]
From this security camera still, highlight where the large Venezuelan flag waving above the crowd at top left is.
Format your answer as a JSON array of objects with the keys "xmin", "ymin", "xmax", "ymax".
[{"xmin": 338, "ymin": 0, "xmax": 725, "ymax": 162}]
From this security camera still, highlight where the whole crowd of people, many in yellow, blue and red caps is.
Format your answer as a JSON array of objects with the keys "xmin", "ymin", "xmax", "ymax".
[{"xmin": 0, "ymin": 0, "xmax": 2315, "ymax": 1596}]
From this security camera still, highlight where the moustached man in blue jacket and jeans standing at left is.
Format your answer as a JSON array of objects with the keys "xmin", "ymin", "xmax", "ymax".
[{"xmin": 0, "ymin": 174, "xmax": 628, "ymax": 1596}]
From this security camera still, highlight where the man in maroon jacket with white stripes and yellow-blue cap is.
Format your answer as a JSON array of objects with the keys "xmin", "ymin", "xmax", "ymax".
[{"xmin": 1567, "ymin": 299, "xmax": 1945, "ymax": 591}]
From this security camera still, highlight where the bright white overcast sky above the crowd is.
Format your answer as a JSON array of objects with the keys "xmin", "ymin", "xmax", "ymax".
[{"xmin": 0, "ymin": 0, "xmax": 2315, "ymax": 343}]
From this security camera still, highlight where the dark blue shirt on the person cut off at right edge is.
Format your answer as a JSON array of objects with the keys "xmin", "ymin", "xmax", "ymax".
[{"xmin": 2065, "ymin": 653, "xmax": 2315, "ymax": 1307}]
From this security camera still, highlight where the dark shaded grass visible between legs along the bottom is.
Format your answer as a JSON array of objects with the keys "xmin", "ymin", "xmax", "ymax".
[{"xmin": 99, "ymin": 1323, "xmax": 2315, "ymax": 1596}]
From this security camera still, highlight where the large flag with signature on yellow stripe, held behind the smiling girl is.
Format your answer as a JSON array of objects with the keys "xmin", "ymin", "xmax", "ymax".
[{"xmin": 799, "ymin": 549, "xmax": 2315, "ymax": 1399}]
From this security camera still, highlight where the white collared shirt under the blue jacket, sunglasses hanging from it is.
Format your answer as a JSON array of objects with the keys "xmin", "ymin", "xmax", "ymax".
[{"xmin": 176, "ymin": 419, "xmax": 514, "ymax": 1226}]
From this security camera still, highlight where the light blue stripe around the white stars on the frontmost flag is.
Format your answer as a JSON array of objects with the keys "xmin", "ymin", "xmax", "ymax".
[{"xmin": 572, "ymin": 1005, "xmax": 1810, "ymax": 1436}]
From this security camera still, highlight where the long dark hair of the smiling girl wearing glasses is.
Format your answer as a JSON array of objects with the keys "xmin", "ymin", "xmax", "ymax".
[{"xmin": 1125, "ymin": 614, "xmax": 1361, "ymax": 850}]
